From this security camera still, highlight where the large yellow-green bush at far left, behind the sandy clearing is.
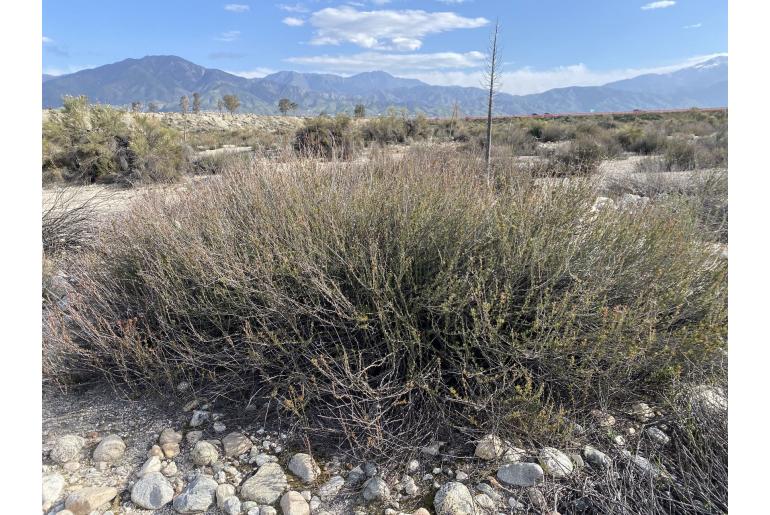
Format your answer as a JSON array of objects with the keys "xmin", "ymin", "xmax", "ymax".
[{"xmin": 43, "ymin": 97, "xmax": 190, "ymax": 185}]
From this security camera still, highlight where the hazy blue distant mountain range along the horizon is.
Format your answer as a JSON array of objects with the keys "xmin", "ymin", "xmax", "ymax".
[{"xmin": 43, "ymin": 56, "xmax": 728, "ymax": 116}]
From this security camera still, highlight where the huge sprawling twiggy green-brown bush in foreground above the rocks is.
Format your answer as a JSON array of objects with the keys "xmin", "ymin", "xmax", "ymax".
[{"xmin": 46, "ymin": 151, "xmax": 727, "ymax": 455}]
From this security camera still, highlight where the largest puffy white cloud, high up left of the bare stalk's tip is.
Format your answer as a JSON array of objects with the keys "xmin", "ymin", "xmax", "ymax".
[{"xmin": 310, "ymin": 6, "xmax": 489, "ymax": 51}]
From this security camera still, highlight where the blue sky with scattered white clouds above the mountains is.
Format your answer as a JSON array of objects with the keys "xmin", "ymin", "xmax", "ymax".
[{"xmin": 43, "ymin": 0, "xmax": 727, "ymax": 94}]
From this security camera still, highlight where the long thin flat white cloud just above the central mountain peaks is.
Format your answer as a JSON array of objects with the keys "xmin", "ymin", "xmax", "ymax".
[{"xmin": 286, "ymin": 52, "xmax": 484, "ymax": 74}]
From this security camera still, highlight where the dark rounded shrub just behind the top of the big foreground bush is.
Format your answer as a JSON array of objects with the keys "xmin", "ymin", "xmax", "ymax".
[{"xmin": 294, "ymin": 115, "xmax": 355, "ymax": 159}]
